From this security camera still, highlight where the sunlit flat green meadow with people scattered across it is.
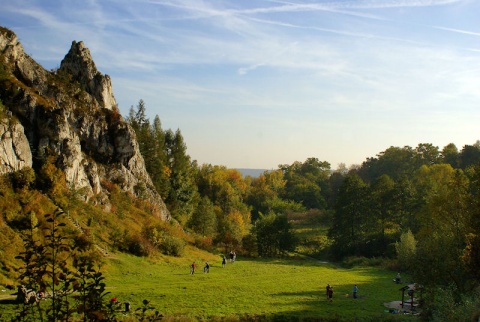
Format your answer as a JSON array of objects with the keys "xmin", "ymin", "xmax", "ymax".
[{"xmin": 0, "ymin": 252, "xmax": 413, "ymax": 321}]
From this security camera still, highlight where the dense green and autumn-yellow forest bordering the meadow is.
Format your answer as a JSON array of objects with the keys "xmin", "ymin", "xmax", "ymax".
[{"xmin": 127, "ymin": 100, "xmax": 480, "ymax": 317}]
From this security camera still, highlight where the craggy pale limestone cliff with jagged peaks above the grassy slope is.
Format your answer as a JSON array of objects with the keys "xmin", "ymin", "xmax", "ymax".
[{"xmin": 0, "ymin": 28, "xmax": 170, "ymax": 220}]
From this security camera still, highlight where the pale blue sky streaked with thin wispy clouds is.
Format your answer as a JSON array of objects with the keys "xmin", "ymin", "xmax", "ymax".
[{"xmin": 0, "ymin": 0, "xmax": 480, "ymax": 169}]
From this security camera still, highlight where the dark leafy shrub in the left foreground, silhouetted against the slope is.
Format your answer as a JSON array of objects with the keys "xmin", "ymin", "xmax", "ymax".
[{"xmin": 13, "ymin": 210, "xmax": 114, "ymax": 321}]
